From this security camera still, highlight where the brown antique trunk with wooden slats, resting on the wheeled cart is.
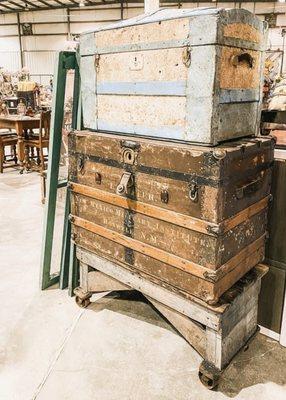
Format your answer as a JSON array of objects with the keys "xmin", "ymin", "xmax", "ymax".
[{"xmin": 69, "ymin": 131, "xmax": 274, "ymax": 302}]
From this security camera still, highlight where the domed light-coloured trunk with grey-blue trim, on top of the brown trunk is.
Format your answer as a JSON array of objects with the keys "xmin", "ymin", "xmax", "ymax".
[{"xmin": 80, "ymin": 8, "xmax": 265, "ymax": 145}]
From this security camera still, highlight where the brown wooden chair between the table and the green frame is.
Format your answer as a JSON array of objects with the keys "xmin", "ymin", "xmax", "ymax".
[{"xmin": 24, "ymin": 111, "xmax": 51, "ymax": 174}]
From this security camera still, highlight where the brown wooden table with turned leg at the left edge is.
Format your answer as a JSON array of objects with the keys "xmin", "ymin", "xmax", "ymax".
[{"xmin": 0, "ymin": 115, "xmax": 40, "ymax": 173}]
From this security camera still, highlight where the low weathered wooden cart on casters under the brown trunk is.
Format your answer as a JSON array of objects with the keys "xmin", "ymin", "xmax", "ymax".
[{"xmin": 74, "ymin": 247, "xmax": 268, "ymax": 389}]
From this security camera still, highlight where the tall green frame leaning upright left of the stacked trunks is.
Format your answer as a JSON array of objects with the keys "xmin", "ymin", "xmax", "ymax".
[{"xmin": 40, "ymin": 51, "xmax": 81, "ymax": 289}]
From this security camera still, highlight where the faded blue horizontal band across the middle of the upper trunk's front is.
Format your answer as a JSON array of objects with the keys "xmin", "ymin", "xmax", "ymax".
[{"xmin": 97, "ymin": 81, "xmax": 187, "ymax": 96}]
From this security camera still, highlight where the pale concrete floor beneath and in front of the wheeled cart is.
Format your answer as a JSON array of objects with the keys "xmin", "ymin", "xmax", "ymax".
[{"xmin": 0, "ymin": 170, "xmax": 286, "ymax": 400}]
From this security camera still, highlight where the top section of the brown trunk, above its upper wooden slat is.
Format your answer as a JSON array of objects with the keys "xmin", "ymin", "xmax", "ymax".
[{"xmin": 70, "ymin": 132, "xmax": 273, "ymax": 223}]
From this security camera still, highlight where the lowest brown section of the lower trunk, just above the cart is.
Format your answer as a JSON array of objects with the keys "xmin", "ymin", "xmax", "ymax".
[{"xmin": 74, "ymin": 219, "xmax": 264, "ymax": 303}]
